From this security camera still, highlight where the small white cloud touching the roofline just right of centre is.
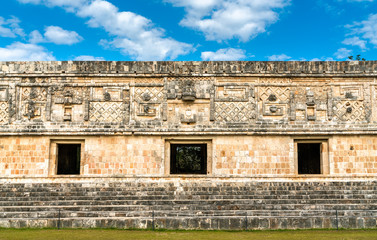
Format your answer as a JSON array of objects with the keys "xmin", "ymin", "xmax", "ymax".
[{"xmin": 201, "ymin": 48, "xmax": 246, "ymax": 61}]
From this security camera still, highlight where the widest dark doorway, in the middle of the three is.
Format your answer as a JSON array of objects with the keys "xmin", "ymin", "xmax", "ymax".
[{"xmin": 170, "ymin": 144, "xmax": 207, "ymax": 174}]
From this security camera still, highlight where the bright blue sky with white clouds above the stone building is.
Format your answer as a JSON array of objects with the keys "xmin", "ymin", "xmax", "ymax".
[{"xmin": 0, "ymin": 0, "xmax": 377, "ymax": 61}]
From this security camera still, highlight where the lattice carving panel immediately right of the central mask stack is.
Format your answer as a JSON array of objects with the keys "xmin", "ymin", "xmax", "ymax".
[{"xmin": 215, "ymin": 102, "xmax": 255, "ymax": 123}]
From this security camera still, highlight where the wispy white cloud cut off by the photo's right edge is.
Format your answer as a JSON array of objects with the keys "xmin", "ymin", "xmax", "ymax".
[{"xmin": 346, "ymin": 14, "xmax": 377, "ymax": 47}]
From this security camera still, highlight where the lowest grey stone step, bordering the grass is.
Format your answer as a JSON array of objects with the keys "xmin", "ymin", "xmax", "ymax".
[{"xmin": 0, "ymin": 216, "xmax": 376, "ymax": 230}]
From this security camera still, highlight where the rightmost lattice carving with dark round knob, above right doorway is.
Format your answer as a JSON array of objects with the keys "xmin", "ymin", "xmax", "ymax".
[{"xmin": 334, "ymin": 101, "xmax": 365, "ymax": 122}]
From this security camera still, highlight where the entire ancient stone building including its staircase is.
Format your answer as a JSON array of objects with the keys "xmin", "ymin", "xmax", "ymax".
[{"xmin": 0, "ymin": 61, "xmax": 377, "ymax": 229}]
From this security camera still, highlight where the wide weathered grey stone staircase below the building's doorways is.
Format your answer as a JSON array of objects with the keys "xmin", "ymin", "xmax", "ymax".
[{"xmin": 0, "ymin": 179, "xmax": 377, "ymax": 229}]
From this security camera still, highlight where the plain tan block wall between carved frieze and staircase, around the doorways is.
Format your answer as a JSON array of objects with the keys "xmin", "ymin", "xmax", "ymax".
[{"xmin": 0, "ymin": 135, "xmax": 377, "ymax": 179}]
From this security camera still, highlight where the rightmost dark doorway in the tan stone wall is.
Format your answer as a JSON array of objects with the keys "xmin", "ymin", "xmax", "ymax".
[{"xmin": 297, "ymin": 143, "xmax": 321, "ymax": 174}]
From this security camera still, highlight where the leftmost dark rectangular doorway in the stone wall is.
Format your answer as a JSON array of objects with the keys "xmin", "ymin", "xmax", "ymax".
[{"xmin": 58, "ymin": 144, "xmax": 81, "ymax": 174}]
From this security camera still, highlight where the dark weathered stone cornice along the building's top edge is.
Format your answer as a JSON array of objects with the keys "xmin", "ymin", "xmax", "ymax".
[{"xmin": 0, "ymin": 61, "xmax": 377, "ymax": 77}]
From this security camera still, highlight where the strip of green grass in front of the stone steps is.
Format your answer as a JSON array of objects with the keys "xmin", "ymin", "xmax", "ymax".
[{"xmin": 0, "ymin": 229, "xmax": 377, "ymax": 240}]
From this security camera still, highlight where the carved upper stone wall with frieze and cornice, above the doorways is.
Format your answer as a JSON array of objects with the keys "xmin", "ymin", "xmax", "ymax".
[{"xmin": 0, "ymin": 62, "xmax": 377, "ymax": 135}]
